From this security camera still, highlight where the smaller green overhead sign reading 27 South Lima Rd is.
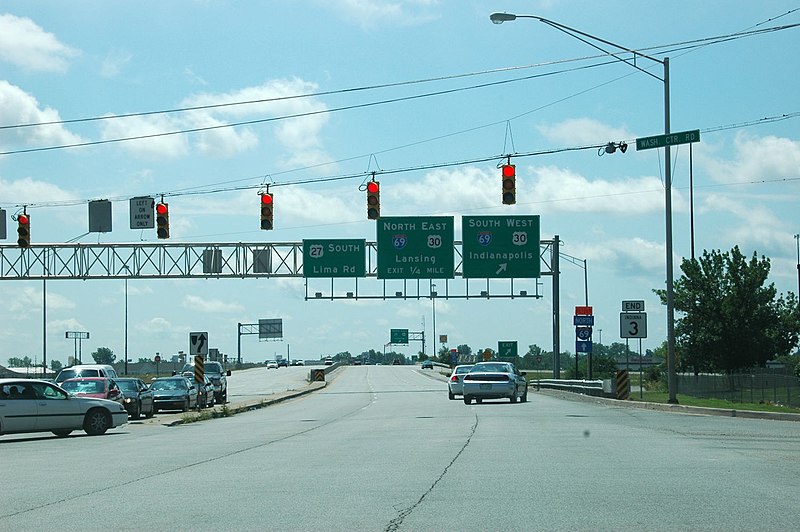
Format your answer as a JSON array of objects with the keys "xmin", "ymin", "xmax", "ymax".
[{"xmin": 303, "ymin": 239, "xmax": 367, "ymax": 277}]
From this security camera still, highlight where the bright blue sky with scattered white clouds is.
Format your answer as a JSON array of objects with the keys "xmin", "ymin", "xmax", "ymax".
[{"xmin": 0, "ymin": 0, "xmax": 800, "ymax": 363}]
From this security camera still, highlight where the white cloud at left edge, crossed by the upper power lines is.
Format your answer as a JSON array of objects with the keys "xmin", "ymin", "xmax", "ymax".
[{"xmin": 0, "ymin": 81, "xmax": 82, "ymax": 151}]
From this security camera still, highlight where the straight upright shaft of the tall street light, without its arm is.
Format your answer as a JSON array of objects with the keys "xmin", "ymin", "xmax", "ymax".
[{"xmin": 664, "ymin": 57, "xmax": 678, "ymax": 404}]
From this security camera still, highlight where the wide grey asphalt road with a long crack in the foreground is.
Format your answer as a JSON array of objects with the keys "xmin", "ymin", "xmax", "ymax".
[{"xmin": 0, "ymin": 366, "xmax": 800, "ymax": 531}]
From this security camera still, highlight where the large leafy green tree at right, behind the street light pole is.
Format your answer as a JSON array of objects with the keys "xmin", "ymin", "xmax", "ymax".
[{"xmin": 655, "ymin": 246, "xmax": 800, "ymax": 373}]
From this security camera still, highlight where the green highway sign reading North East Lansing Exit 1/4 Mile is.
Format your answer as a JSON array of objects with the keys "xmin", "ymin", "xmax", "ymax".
[{"xmin": 376, "ymin": 216, "xmax": 455, "ymax": 279}]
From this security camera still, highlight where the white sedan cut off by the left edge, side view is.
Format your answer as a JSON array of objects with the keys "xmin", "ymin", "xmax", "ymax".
[{"xmin": 0, "ymin": 379, "xmax": 128, "ymax": 437}]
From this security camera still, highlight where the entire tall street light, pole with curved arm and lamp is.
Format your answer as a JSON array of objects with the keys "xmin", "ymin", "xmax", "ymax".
[{"xmin": 489, "ymin": 13, "xmax": 678, "ymax": 404}]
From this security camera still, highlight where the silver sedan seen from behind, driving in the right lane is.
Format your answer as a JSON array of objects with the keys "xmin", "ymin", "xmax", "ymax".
[{"xmin": 461, "ymin": 362, "xmax": 528, "ymax": 404}]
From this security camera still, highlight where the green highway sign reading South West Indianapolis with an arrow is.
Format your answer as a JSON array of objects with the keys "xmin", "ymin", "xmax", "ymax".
[{"xmin": 461, "ymin": 215, "xmax": 541, "ymax": 279}]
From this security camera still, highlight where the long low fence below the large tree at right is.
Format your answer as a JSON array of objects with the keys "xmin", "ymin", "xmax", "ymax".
[{"xmin": 678, "ymin": 369, "xmax": 800, "ymax": 407}]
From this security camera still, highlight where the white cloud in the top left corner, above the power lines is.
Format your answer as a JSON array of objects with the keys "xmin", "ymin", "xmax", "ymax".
[{"xmin": 0, "ymin": 13, "xmax": 79, "ymax": 72}]
